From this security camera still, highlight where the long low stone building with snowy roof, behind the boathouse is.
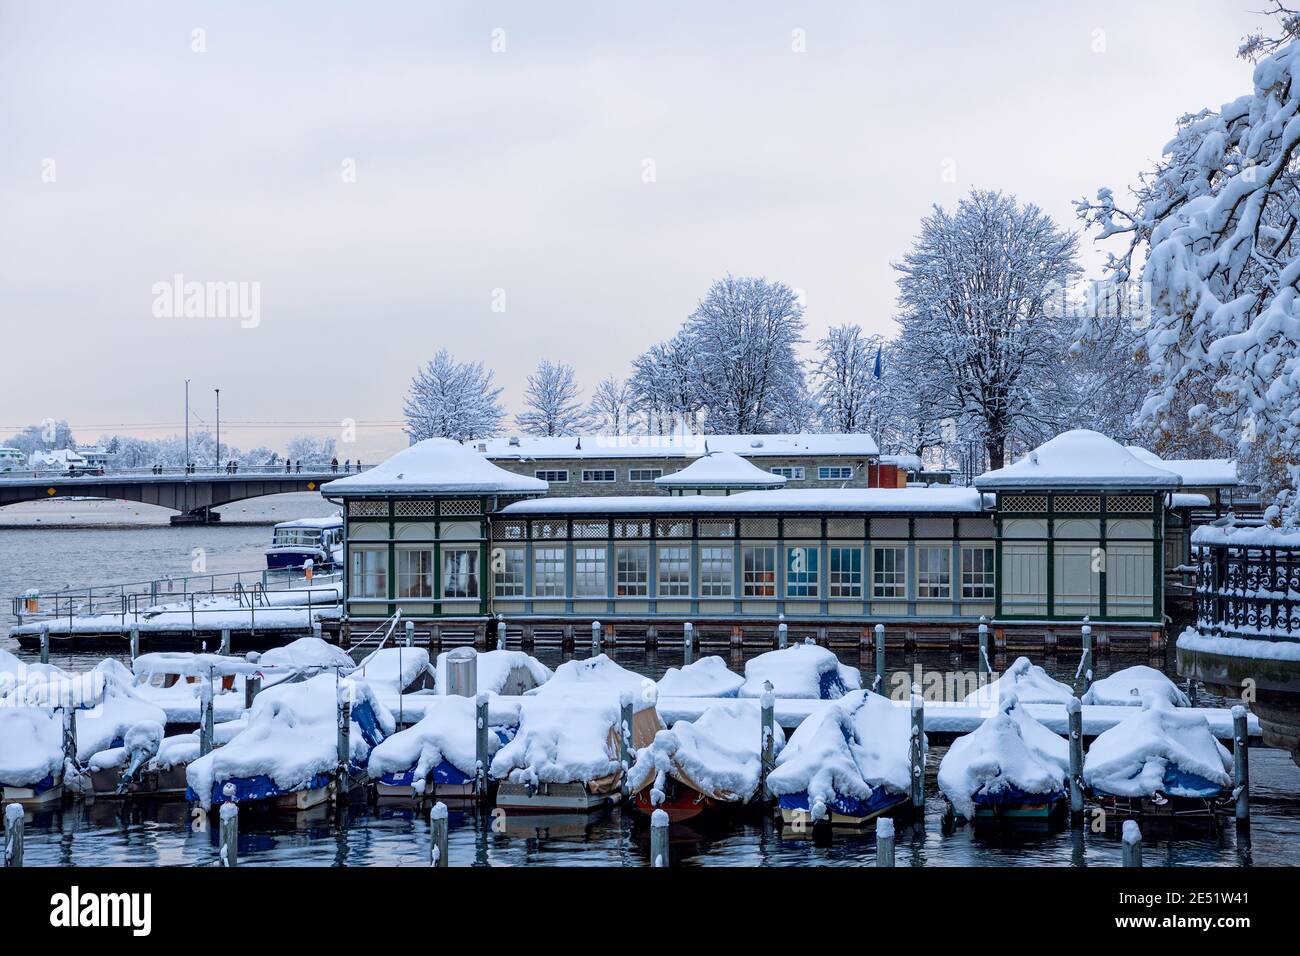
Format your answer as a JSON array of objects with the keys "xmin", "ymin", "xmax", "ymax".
[{"xmin": 467, "ymin": 434, "xmax": 883, "ymax": 498}]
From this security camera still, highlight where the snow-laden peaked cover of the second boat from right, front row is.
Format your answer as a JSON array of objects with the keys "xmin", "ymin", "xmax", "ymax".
[{"xmin": 939, "ymin": 695, "xmax": 1070, "ymax": 819}]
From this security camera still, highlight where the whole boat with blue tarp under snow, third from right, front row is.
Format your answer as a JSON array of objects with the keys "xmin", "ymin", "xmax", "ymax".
[{"xmin": 767, "ymin": 691, "xmax": 926, "ymax": 834}]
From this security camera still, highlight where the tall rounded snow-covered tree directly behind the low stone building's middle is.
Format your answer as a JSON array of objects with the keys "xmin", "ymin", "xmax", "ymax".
[{"xmin": 683, "ymin": 276, "xmax": 810, "ymax": 434}]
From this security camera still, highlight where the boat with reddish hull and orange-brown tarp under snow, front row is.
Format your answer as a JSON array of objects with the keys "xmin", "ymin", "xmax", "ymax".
[{"xmin": 628, "ymin": 700, "xmax": 785, "ymax": 822}]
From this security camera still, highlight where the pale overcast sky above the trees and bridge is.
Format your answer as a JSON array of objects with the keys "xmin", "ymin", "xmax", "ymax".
[{"xmin": 0, "ymin": 0, "xmax": 1268, "ymax": 460}]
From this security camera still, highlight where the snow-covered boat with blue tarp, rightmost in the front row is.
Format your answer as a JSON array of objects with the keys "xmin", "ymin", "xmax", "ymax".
[{"xmin": 1083, "ymin": 691, "xmax": 1232, "ymax": 822}]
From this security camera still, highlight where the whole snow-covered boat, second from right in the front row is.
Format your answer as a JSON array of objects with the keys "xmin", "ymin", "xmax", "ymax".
[{"xmin": 939, "ymin": 692, "xmax": 1070, "ymax": 829}]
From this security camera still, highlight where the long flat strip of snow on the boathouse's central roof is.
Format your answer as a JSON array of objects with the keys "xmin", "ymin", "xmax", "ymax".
[{"xmin": 498, "ymin": 488, "xmax": 983, "ymax": 518}]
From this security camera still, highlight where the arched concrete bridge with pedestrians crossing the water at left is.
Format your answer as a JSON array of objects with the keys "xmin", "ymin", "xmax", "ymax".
[{"xmin": 0, "ymin": 468, "xmax": 346, "ymax": 524}]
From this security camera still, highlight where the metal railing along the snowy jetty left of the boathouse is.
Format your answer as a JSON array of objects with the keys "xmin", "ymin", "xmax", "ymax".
[{"xmin": 12, "ymin": 566, "xmax": 341, "ymax": 624}]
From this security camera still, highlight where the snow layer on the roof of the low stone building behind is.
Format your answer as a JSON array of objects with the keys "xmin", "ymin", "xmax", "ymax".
[{"xmin": 467, "ymin": 434, "xmax": 880, "ymax": 459}]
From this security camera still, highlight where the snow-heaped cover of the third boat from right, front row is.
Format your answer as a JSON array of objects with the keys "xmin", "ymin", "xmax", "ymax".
[{"xmin": 767, "ymin": 691, "xmax": 911, "ymax": 821}]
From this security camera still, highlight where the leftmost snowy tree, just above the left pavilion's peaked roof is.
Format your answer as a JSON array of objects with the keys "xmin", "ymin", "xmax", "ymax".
[{"xmin": 403, "ymin": 349, "xmax": 506, "ymax": 441}]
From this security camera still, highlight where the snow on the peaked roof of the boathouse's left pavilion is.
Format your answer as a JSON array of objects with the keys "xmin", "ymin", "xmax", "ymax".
[{"xmin": 321, "ymin": 438, "xmax": 547, "ymax": 496}]
